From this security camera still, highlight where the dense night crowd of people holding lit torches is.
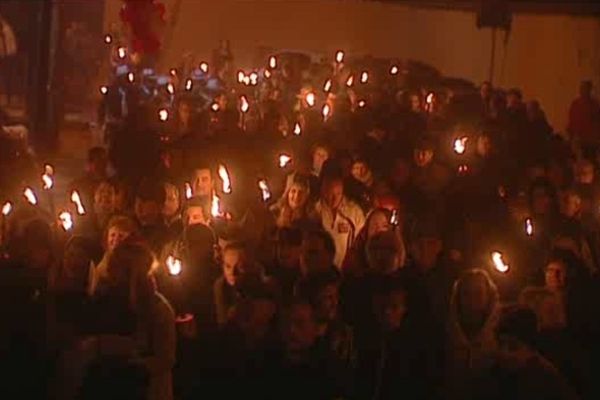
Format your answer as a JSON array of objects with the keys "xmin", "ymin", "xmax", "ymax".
[{"xmin": 0, "ymin": 39, "xmax": 600, "ymax": 400}]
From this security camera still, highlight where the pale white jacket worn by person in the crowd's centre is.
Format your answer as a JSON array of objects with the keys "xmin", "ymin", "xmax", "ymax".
[{"xmin": 315, "ymin": 197, "xmax": 365, "ymax": 268}]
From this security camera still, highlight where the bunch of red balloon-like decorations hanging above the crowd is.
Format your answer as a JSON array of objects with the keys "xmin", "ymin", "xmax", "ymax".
[{"xmin": 120, "ymin": 0, "xmax": 166, "ymax": 54}]
